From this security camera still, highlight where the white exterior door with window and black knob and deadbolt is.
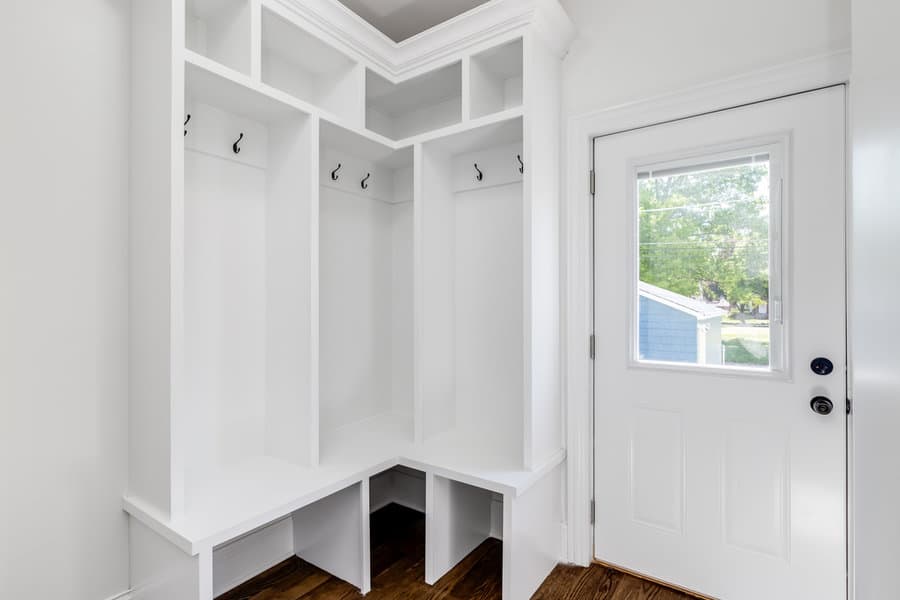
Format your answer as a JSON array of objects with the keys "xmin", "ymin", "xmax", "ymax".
[{"xmin": 594, "ymin": 87, "xmax": 846, "ymax": 600}]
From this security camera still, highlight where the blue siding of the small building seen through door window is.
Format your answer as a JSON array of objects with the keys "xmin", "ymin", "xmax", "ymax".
[{"xmin": 639, "ymin": 296, "xmax": 697, "ymax": 363}]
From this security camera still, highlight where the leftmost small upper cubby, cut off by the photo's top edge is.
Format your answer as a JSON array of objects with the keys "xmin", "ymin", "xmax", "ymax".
[{"xmin": 184, "ymin": 0, "xmax": 252, "ymax": 75}]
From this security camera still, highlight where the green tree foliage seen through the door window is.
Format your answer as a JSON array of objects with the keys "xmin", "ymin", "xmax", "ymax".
[{"xmin": 638, "ymin": 164, "xmax": 769, "ymax": 313}]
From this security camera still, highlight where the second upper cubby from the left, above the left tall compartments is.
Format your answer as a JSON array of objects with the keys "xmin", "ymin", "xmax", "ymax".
[{"xmin": 262, "ymin": 7, "xmax": 364, "ymax": 126}]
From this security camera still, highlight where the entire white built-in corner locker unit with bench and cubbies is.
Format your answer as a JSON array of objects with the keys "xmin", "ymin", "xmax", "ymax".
[{"xmin": 124, "ymin": 0, "xmax": 572, "ymax": 600}]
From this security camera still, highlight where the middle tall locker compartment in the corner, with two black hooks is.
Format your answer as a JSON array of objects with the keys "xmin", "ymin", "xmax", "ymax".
[{"xmin": 319, "ymin": 121, "xmax": 413, "ymax": 462}]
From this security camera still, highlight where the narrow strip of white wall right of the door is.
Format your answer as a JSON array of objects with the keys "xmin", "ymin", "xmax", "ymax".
[{"xmin": 850, "ymin": 0, "xmax": 900, "ymax": 600}]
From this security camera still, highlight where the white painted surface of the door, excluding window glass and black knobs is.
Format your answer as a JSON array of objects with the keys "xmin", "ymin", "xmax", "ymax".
[{"xmin": 595, "ymin": 86, "xmax": 846, "ymax": 600}]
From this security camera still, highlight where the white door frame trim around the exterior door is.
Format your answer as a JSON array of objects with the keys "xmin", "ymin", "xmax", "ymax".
[{"xmin": 561, "ymin": 51, "xmax": 853, "ymax": 584}]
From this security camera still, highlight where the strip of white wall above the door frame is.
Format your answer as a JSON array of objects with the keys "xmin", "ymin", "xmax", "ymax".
[{"xmin": 561, "ymin": 0, "xmax": 850, "ymax": 116}]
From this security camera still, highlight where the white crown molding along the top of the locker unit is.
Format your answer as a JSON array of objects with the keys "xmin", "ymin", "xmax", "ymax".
[{"xmin": 263, "ymin": 0, "xmax": 575, "ymax": 83}]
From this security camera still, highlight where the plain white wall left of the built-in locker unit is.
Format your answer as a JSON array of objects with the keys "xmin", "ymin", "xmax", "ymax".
[{"xmin": 0, "ymin": 0, "xmax": 129, "ymax": 600}]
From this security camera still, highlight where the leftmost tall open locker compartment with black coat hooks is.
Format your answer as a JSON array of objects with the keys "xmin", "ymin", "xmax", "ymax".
[{"xmin": 176, "ymin": 65, "xmax": 315, "ymax": 502}]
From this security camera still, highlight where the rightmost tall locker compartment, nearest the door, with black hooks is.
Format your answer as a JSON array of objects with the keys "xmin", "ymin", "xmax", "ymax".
[{"xmin": 418, "ymin": 118, "xmax": 525, "ymax": 469}]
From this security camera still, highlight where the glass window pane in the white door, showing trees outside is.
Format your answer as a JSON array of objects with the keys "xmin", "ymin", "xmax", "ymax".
[{"xmin": 636, "ymin": 155, "xmax": 771, "ymax": 368}]
